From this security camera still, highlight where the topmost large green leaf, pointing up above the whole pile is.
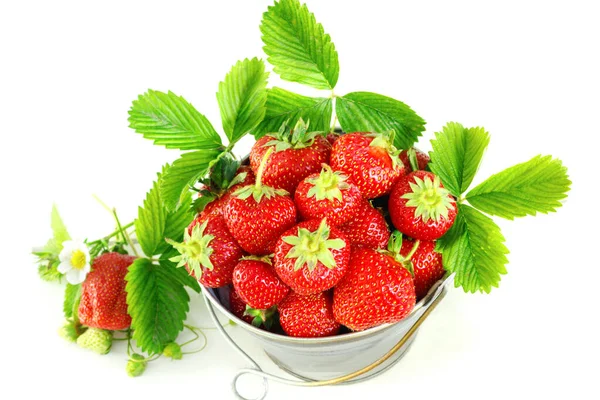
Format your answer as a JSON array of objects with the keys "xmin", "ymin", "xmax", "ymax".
[{"xmin": 260, "ymin": 0, "xmax": 340, "ymax": 90}]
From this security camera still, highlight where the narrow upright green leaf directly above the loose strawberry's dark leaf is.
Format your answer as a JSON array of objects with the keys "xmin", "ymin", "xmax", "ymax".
[{"xmin": 135, "ymin": 169, "xmax": 167, "ymax": 257}]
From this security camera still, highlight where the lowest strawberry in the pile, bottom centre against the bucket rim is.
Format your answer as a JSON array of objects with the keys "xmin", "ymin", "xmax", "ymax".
[{"xmin": 279, "ymin": 292, "xmax": 340, "ymax": 338}]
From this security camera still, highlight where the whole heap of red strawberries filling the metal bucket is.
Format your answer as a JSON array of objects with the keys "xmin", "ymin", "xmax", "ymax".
[{"xmin": 172, "ymin": 120, "xmax": 457, "ymax": 337}]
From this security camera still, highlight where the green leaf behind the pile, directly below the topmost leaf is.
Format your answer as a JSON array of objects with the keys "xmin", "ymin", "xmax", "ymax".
[{"xmin": 252, "ymin": 87, "xmax": 332, "ymax": 139}]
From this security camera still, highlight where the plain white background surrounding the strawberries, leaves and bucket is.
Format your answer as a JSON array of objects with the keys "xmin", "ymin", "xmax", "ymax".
[{"xmin": 0, "ymin": 0, "xmax": 600, "ymax": 399}]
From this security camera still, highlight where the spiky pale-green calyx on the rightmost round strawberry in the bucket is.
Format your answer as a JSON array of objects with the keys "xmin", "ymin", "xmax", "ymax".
[{"xmin": 402, "ymin": 176, "xmax": 454, "ymax": 222}]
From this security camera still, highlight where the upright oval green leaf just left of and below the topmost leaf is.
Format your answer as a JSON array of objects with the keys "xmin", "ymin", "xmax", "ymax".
[{"xmin": 217, "ymin": 58, "xmax": 269, "ymax": 144}]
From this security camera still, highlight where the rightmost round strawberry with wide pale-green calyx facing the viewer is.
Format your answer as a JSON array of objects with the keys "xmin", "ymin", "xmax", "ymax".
[{"xmin": 388, "ymin": 171, "xmax": 456, "ymax": 240}]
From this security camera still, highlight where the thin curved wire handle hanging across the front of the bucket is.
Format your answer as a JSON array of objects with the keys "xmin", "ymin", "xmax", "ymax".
[{"xmin": 203, "ymin": 284, "xmax": 448, "ymax": 400}]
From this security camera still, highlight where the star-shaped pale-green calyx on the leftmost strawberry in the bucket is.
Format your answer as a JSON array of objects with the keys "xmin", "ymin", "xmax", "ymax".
[{"xmin": 165, "ymin": 221, "xmax": 215, "ymax": 278}]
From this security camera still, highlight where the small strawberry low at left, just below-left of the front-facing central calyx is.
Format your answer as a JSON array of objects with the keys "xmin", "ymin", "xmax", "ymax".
[{"xmin": 233, "ymin": 258, "xmax": 290, "ymax": 310}]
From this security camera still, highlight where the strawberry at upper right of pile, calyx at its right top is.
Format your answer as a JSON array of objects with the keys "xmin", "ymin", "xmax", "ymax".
[{"xmin": 330, "ymin": 132, "xmax": 404, "ymax": 199}]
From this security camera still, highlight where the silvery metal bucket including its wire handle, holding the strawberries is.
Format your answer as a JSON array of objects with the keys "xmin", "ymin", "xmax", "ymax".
[{"xmin": 203, "ymin": 275, "xmax": 453, "ymax": 399}]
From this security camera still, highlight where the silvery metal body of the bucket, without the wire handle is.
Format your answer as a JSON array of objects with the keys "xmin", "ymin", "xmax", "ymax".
[{"xmin": 204, "ymin": 277, "xmax": 451, "ymax": 382}]
